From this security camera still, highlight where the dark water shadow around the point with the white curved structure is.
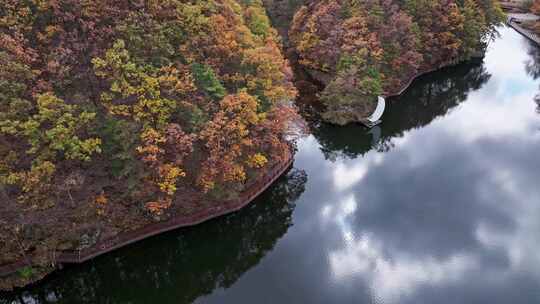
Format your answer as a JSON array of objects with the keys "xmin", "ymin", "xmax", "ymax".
[{"xmin": 299, "ymin": 60, "xmax": 491, "ymax": 160}]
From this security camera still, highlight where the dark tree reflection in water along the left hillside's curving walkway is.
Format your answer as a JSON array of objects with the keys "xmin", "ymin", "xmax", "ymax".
[{"xmin": 0, "ymin": 169, "xmax": 307, "ymax": 304}]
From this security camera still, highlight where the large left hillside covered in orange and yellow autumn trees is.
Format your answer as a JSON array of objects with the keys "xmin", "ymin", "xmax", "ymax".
[{"xmin": 0, "ymin": 0, "xmax": 296, "ymax": 290}]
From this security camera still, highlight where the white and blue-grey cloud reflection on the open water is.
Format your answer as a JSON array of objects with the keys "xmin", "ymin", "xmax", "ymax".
[{"xmin": 318, "ymin": 30, "xmax": 540, "ymax": 303}]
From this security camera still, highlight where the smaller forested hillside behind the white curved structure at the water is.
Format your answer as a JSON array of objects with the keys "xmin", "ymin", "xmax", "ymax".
[{"xmin": 289, "ymin": 0, "xmax": 502, "ymax": 124}]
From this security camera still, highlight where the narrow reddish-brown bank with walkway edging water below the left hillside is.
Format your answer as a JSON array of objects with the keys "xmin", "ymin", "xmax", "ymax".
[{"xmin": 0, "ymin": 151, "xmax": 294, "ymax": 290}]
